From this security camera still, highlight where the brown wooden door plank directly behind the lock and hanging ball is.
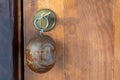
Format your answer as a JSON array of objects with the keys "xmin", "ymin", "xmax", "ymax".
[{"xmin": 24, "ymin": 0, "xmax": 64, "ymax": 80}]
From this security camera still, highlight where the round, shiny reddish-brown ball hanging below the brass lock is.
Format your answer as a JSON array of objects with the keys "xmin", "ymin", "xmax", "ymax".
[{"xmin": 25, "ymin": 35, "xmax": 56, "ymax": 73}]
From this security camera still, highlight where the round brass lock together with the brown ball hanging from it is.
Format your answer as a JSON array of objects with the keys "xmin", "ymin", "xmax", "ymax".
[{"xmin": 25, "ymin": 9, "xmax": 56, "ymax": 73}]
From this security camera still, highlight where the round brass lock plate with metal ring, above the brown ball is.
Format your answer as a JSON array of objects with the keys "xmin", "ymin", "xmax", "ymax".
[{"xmin": 34, "ymin": 9, "xmax": 56, "ymax": 32}]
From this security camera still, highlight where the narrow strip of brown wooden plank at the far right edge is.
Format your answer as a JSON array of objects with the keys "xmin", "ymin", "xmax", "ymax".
[{"xmin": 114, "ymin": 0, "xmax": 120, "ymax": 80}]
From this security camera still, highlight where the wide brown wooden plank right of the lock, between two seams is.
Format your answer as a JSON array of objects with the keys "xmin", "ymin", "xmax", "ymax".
[{"xmin": 64, "ymin": 0, "xmax": 114, "ymax": 80}]
